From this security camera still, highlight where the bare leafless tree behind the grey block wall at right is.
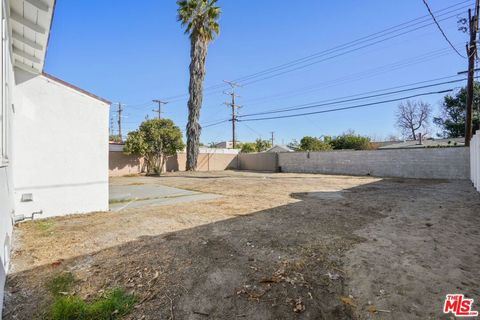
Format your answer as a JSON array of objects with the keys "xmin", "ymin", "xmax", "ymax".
[{"xmin": 396, "ymin": 100, "xmax": 432, "ymax": 140}]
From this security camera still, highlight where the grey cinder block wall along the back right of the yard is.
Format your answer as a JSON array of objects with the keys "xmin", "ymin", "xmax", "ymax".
[{"xmin": 278, "ymin": 147, "xmax": 470, "ymax": 179}]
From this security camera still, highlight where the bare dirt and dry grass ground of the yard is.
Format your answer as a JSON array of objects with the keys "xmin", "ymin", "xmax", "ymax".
[{"xmin": 4, "ymin": 172, "xmax": 480, "ymax": 320}]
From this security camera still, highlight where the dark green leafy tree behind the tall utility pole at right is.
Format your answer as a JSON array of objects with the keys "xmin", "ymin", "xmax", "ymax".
[{"xmin": 433, "ymin": 82, "xmax": 480, "ymax": 138}]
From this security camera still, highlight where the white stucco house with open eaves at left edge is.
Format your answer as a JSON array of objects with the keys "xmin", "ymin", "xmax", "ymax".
[{"xmin": 0, "ymin": 0, "xmax": 110, "ymax": 319}]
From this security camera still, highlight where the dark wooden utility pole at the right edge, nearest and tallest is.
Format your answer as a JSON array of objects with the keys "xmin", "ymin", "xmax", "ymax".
[{"xmin": 465, "ymin": 0, "xmax": 480, "ymax": 147}]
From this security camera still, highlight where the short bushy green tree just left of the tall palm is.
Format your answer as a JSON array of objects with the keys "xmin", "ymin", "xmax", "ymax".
[{"xmin": 124, "ymin": 119, "xmax": 185, "ymax": 174}]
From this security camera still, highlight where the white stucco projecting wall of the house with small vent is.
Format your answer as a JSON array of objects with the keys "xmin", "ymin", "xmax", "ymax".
[{"xmin": 14, "ymin": 70, "xmax": 109, "ymax": 218}]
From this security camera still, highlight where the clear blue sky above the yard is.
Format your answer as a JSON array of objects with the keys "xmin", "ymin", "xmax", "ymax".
[{"xmin": 45, "ymin": 0, "xmax": 474, "ymax": 143}]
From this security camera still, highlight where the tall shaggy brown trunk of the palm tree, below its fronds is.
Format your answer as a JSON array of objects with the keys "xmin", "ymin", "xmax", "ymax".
[{"xmin": 186, "ymin": 34, "xmax": 207, "ymax": 171}]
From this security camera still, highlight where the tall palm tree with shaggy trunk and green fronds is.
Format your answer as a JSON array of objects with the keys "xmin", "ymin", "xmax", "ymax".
[{"xmin": 177, "ymin": 0, "xmax": 221, "ymax": 171}]
